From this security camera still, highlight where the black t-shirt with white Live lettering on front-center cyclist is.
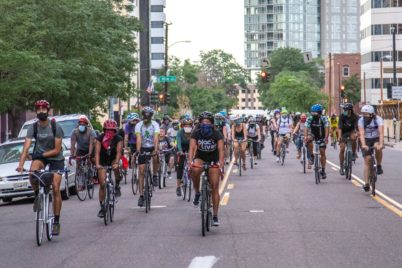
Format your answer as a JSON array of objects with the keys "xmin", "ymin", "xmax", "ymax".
[{"xmin": 191, "ymin": 129, "xmax": 223, "ymax": 162}]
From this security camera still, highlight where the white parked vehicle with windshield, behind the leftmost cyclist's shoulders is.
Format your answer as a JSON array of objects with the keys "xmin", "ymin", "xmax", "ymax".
[{"xmin": 18, "ymin": 114, "xmax": 92, "ymax": 150}]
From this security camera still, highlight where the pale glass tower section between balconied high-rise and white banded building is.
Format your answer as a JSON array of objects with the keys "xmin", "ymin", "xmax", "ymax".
[{"xmin": 321, "ymin": 0, "xmax": 360, "ymax": 58}]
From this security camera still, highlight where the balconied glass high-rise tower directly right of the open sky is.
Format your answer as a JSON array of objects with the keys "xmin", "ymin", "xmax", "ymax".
[{"xmin": 244, "ymin": 0, "xmax": 321, "ymax": 70}]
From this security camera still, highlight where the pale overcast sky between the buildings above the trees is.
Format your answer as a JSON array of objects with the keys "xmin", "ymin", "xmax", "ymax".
[{"xmin": 165, "ymin": 0, "xmax": 244, "ymax": 65}]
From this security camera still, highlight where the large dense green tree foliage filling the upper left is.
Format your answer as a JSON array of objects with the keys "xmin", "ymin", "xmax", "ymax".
[{"xmin": 0, "ymin": 0, "xmax": 141, "ymax": 124}]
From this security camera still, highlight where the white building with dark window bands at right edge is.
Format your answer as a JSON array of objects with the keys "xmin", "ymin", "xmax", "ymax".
[{"xmin": 360, "ymin": 0, "xmax": 402, "ymax": 105}]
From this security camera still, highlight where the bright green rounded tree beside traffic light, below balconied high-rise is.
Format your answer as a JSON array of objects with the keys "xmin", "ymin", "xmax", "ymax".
[{"xmin": 269, "ymin": 71, "xmax": 326, "ymax": 111}]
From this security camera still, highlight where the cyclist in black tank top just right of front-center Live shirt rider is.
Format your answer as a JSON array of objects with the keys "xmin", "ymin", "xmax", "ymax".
[{"xmin": 232, "ymin": 115, "xmax": 247, "ymax": 170}]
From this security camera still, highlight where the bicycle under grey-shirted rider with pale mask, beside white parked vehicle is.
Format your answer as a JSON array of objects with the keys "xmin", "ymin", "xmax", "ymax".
[{"xmin": 73, "ymin": 156, "xmax": 95, "ymax": 201}]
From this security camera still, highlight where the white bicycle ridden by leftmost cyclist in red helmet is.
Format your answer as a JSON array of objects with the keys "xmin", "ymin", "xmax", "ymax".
[{"xmin": 24, "ymin": 169, "xmax": 70, "ymax": 246}]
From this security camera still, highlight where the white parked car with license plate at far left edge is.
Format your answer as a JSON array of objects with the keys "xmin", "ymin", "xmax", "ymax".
[{"xmin": 0, "ymin": 138, "xmax": 75, "ymax": 202}]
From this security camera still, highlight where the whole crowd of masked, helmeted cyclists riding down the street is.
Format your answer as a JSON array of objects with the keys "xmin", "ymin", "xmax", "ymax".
[{"xmin": 17, "ymin": 100, "xmax": 384, "ymax": 235}]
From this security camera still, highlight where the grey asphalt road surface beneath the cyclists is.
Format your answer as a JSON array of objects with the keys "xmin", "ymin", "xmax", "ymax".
[{"xmin": 0, "ymin": 138, "xmax": 402, "ymax": 267}]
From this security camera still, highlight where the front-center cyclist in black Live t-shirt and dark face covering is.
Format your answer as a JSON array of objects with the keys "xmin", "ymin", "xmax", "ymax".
[{"xmin": 188, "ymin": 112, "xmax": 225, "ymax": 226}]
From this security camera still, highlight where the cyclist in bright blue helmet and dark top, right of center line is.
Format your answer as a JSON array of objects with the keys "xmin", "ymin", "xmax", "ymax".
[{"xmin": 304, "ymin": 104, "xmax": 329, "ymax": 179}]
